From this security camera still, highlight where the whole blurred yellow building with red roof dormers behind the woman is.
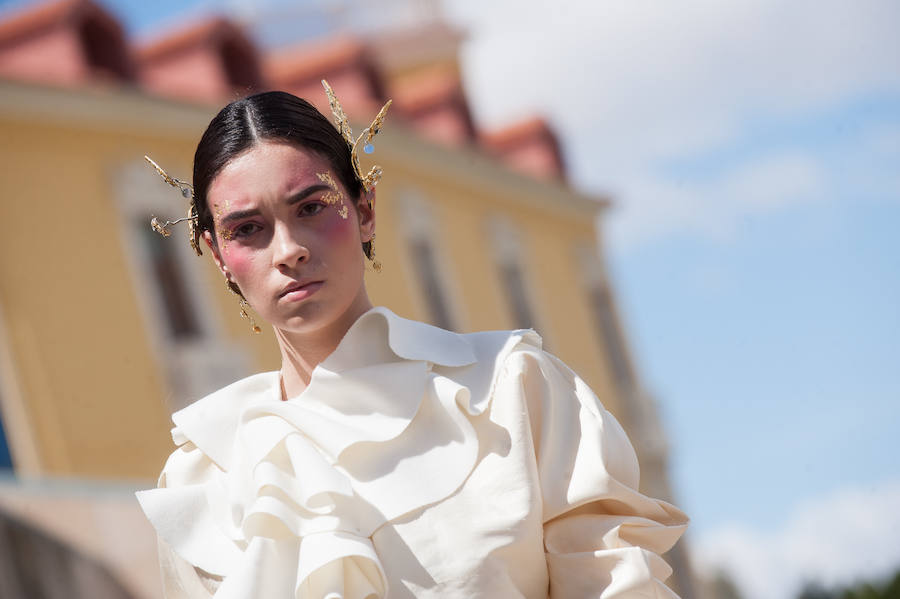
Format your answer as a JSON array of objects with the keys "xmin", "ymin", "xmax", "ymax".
[{"xmin": 0, "ymin": 0, "xmax": 692, "ymax": 599}]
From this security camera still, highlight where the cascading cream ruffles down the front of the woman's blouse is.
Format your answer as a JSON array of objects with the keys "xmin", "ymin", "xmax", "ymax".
[{"xmin": 138, "ymin": 309, "xmax": 509, "ymax": 599}]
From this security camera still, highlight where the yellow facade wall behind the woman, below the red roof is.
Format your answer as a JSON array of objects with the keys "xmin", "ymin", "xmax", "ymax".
[{"xmin": 0, "ymin": 81, "xmax": 627, "ymax": 478}]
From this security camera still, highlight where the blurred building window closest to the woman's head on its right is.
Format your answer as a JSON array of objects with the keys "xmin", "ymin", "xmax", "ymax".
[{"xmin": 398, "ymin": 190, "xmax": 457, "ymax": 330}]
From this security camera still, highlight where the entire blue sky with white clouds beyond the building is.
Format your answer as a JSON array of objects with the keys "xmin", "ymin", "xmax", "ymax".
[{"xmin": 5, "ymin": 0, "xmax": 900, "ymax": 599}]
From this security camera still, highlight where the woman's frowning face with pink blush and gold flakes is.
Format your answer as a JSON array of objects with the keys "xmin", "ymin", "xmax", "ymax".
[{"xmin": 204, "ymin": 141, "xmax": 375, "ymax": 334}]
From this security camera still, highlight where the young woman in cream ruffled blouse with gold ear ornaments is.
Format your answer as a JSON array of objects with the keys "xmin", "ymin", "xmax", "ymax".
[{"xmin": 139, "ymin": 90, "xmax": 686, "ymax": 599}]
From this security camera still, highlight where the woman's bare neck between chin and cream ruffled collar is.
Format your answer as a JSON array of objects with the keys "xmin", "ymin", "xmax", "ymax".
[{"xmin": 275, "ymin": 293, "xmax": 372, "ymax": 399}]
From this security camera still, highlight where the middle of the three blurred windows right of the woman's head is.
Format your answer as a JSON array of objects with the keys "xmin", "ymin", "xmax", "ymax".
[{"xmin": 488, "ymin": 217, "xmax": 538, "ymax": 329}]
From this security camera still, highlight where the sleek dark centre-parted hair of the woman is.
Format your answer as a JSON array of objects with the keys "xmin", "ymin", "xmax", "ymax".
[{"xmin": 193, "ymin": 91, "xmax": 372, "ymax": 257}]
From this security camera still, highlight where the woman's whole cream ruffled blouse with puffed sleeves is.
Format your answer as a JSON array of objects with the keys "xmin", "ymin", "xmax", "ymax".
[{"xmin": 138, "ymin": 308, "xmax": 687, "ymax": 599}]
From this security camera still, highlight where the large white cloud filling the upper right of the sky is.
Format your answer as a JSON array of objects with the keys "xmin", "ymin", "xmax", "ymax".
[{"xmin": 445, "ymin": 0, "xmax": 900, "ymax": 251}]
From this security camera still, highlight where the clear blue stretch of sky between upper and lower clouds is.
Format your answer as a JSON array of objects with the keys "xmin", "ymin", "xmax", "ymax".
[{"xmin": 613, "ymin": 96, "xmax": 900, "ymax": 534}]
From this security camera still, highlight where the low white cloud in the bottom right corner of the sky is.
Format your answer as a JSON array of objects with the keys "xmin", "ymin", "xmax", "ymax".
[{"xmin": 693, "ymin": 482, "xmax": 900, "ymax": 599}]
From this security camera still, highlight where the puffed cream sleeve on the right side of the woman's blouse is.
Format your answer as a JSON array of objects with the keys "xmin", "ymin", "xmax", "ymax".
[{"xmin": 505, "ymin": 346, "xmax": 687, "ymax": 599}]
